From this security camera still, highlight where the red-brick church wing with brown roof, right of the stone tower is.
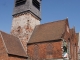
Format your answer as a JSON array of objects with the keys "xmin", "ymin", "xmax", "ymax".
[{"xmin": 27, "ymin": 19, "xmax": 77, "ymax": 60}]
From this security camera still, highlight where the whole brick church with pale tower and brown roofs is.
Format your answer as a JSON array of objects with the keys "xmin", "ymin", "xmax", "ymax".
[{"xmin": 0, "ymin": 0, "xmax": 78, "ymax": 60}]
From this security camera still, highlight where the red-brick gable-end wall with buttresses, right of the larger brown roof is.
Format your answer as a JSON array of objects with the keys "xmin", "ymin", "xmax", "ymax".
[{"xmin": 64, "ymin": 24, "xmax": 78, "ymax": 60}]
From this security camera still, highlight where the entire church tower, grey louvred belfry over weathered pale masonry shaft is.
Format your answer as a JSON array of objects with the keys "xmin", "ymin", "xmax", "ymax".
[{"xmin": 11, "ymin": 0, "xmax": 41, "ymax": 50}]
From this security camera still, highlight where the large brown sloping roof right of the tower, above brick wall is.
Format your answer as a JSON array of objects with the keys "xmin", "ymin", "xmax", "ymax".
[{"xmin": 28, "ymin": 19, "xmax": 68, "ymax": 44}]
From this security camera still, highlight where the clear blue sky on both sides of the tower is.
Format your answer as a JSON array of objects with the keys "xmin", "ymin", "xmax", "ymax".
[{"xmin": 0, "ymin": 0, "xmax": 80, "ymax": 33}]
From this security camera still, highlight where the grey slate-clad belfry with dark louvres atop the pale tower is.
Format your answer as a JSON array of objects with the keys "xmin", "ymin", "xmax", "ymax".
[{"xmin": 13, "ymin": 0, "xmax": 41, "ymax": 19}]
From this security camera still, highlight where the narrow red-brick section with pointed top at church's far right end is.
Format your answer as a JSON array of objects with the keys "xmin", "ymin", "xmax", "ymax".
[{"xmin": 70, "ymin": 28, "xmax": 78, "ymax": 60}]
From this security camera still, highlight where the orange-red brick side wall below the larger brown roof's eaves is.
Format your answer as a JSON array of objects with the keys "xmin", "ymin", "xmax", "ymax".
[{"xmin": 28, "ymin": 41, "xmax": 62, "ymax": 60}]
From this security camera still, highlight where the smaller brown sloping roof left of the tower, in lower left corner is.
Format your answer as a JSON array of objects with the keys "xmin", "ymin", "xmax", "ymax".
[{"xmin": 0, "ymin": 31, "xmax": 27, "ymax": 57}]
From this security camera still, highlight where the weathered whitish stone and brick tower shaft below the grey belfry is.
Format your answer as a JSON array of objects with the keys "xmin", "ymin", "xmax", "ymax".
[{"xmin": 11, "ymin": 13, "xmax": 40, "ymax": 51}]
